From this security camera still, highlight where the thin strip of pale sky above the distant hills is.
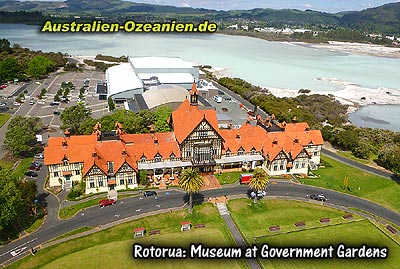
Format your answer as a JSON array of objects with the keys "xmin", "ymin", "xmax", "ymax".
[{"xmin": 125, "ymin": 0, "xmax": 400, "ymax": 13}]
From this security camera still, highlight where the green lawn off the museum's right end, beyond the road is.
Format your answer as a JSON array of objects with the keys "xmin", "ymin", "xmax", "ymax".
[{"xmin": 300, "ymin": 156, "xmax": 400, "ymax": 212}]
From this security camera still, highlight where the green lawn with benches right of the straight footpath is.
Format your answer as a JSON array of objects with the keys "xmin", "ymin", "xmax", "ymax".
[{"xmin": 229, "ymin": 199, "xmax": 400, "ymax": 269}]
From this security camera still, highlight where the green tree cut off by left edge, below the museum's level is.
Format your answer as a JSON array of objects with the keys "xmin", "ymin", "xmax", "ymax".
[{"xmin": 0, "ymin": 169, "xmax": 22, "ymax": 231}]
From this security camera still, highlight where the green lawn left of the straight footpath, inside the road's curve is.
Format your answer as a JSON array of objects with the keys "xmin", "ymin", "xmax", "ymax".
[{"xmin": 9, "ymin": 204, "xmax": 245, "ymax": 269}]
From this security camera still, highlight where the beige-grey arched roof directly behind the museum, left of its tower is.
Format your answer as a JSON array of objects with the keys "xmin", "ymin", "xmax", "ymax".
[{"xmin": 142, "ymin": 85, "xmax": 190, "ymax": 109}]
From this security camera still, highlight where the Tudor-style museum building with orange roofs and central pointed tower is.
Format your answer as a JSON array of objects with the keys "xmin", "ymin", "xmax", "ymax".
[{"xmin": 44, "ymin": 83, "xmax": 323, "ymax": 194}]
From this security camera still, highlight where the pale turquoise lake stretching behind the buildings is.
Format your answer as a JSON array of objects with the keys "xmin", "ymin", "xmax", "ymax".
[{"xmin": 0, "ymin": 24, "xmax": 400, "ymax": 128}]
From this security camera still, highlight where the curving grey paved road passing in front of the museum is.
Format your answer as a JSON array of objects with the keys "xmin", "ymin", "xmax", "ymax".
[{"xmin": 0, "ymin": 183, "xmax": 400, "ymax": 263}]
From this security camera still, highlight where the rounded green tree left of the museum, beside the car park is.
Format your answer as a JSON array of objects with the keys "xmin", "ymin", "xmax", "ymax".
[{"xmin": 4, "ymin": 116, "xmax": 40, "ymax": 156}]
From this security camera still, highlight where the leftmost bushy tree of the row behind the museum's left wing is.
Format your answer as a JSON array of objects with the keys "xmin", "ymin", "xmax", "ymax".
[{"xmin": 60, "ymin": 105, "xmax": 91, "ymax": 134}]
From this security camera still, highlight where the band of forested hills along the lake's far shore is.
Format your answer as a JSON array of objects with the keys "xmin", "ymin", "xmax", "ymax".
[{"xmin": 0, "ymin": 0, "xmax": 400, "ymax": 34}]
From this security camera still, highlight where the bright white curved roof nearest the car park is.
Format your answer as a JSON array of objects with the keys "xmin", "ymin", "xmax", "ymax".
[{"xmin": 106, "ymin": 63, "xmax": 143, "ymax": 96}]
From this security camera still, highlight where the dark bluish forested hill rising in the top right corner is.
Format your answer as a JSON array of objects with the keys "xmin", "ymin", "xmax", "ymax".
[{"xmin": 340, "ymin": 2, "xmax": 400, "ymax": 33}]
